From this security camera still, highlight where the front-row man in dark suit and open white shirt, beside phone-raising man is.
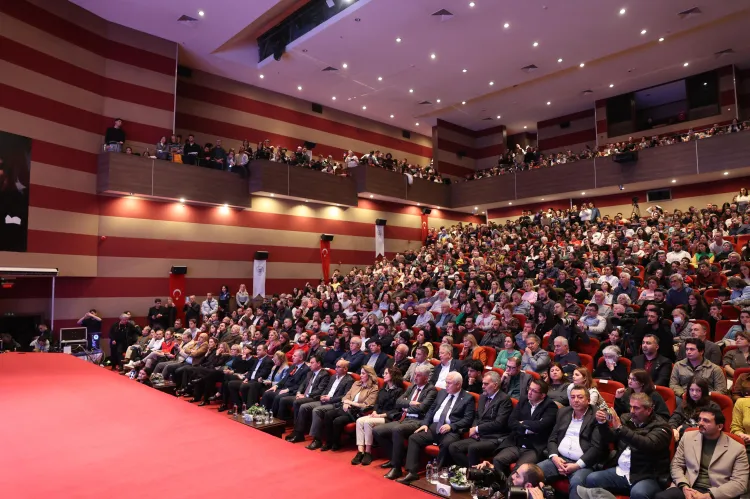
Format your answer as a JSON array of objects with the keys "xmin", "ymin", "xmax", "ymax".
[{"xmin": 539, "ymin": 386, "xmax": 604, "ymax": 499}]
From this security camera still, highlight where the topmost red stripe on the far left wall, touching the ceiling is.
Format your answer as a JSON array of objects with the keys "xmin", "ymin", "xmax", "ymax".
[{"xmin": 0, "ymin": 0, "xmax": 176, "ymax": 76}]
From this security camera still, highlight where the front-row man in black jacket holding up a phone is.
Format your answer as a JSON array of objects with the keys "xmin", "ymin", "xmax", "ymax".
[{"xmin": 586, "ymin": 393, "xmax": 672, "ymax": 499}]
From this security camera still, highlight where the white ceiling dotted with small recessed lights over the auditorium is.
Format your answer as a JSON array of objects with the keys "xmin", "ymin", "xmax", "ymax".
[{"xmin": 72, "ymin": 0, "xmax": 750, "ymax": 134}]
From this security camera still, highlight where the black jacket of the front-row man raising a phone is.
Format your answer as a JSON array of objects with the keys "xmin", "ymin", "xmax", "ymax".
[{"xmin": 599, "ymin": 414, "xmax": 672, "ymax": 484}]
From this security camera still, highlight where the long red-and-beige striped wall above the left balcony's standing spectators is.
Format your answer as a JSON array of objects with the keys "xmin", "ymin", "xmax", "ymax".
[{"xmin": 176, "ymin": 71, "xmax": 432, "ymax": 170}]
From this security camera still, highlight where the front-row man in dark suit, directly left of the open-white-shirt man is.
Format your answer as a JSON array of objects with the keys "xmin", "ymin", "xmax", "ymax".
[{"xmin": 492, "ymin": 380, "xmax": 557, "ymax": 474}]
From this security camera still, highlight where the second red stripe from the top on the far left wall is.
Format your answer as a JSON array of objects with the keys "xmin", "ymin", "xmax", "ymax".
[{"xmin": 0, "ymin": 36, "xmax": 174, "ymax": 112}]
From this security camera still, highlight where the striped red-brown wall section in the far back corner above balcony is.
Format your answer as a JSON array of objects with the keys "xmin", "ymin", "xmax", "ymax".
[{"xmin": 432, "ymin": 119, "xmax": 506, "ymax": 177}]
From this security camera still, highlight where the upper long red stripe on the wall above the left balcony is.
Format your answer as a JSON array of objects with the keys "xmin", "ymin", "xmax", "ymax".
[{"xmin": 177, "ymin": 80, "xmax": 432, "ymax": 158}]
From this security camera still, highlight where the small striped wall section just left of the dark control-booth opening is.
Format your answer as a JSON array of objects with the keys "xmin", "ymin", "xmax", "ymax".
[{"xmin": 536, "ymin": 109, "xmax": 596, "ymax": 153}]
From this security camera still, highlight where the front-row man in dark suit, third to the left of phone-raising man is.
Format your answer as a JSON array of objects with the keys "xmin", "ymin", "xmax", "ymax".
[{"xmin": 448, "ymin": 371, "xmax": 513, "ymax": 468}]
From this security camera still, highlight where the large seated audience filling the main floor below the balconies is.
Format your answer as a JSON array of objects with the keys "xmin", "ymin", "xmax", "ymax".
[{"xmin": 23, "ymin": 188, "xmax": 750, "ymax": 499}]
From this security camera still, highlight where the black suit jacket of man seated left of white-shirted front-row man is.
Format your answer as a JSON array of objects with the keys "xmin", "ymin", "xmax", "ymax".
[{"xmin": 498, "ymin": 397, "xmax": 557, "ymax": 456}]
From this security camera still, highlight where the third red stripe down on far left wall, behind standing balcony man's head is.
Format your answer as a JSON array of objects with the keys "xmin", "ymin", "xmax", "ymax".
[{"xmin": 0, "ymin": 84, "xmax": 172, "ymax": 144}]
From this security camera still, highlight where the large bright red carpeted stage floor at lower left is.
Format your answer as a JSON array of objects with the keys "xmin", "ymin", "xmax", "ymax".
[{"xmin": 0, "ymin": 353, "xmax": 428, "ymax": 499}]
